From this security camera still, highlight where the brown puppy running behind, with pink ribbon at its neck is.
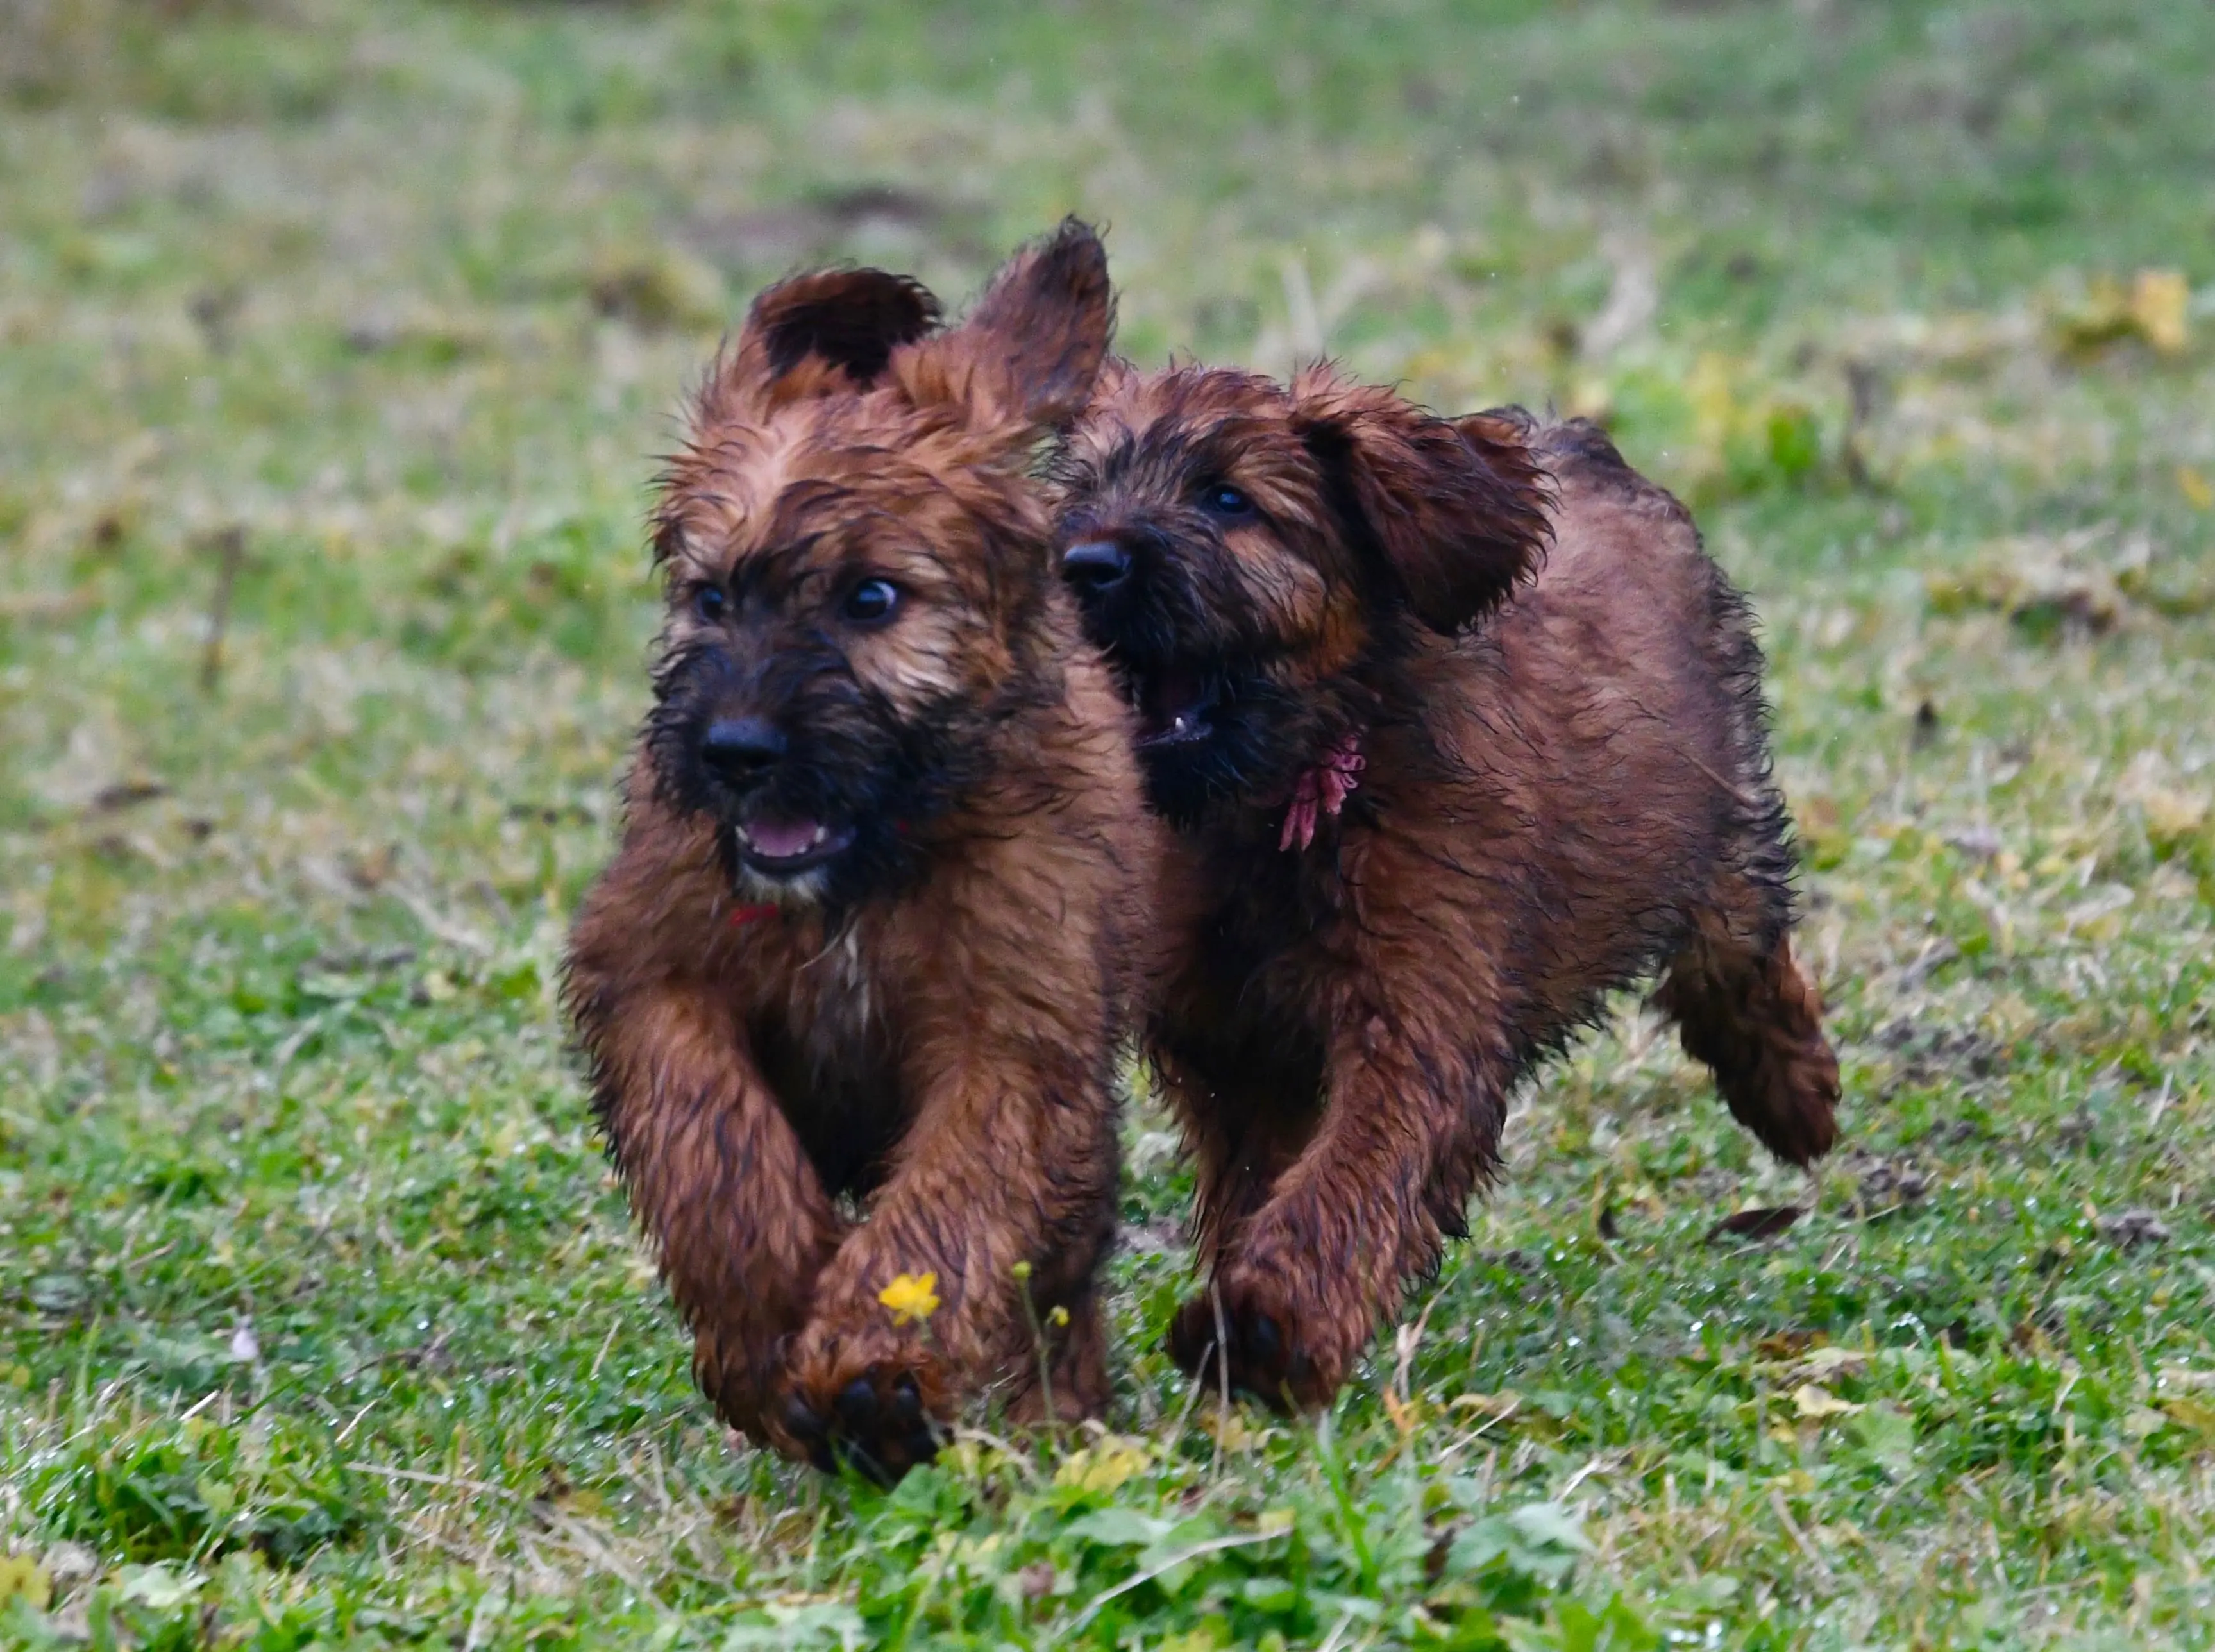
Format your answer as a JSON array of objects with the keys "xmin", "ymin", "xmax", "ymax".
[{"xmin": 1059, "ymin": 367, "xmax": 1839, "ymax": 1404}]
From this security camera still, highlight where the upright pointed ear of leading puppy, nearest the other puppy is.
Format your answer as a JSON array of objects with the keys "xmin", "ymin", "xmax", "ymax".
[{"xmin": 902, "ymin": 217, "xmax": 1114, "ymax": 430}]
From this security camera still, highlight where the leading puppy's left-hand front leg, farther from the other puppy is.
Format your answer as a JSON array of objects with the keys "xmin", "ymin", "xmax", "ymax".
[{"xmin": 571, "ymin": 970, "xmax": 842, "ymax": 1457}]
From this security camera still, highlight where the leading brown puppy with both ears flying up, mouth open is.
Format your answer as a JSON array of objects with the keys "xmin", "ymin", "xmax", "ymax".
[{"xmin": 567, "ymin": 221, "xmax": 1158, "ymax": 1477}]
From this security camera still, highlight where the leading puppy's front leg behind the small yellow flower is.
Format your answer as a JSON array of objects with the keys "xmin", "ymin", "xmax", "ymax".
[{"xmin": 786, "ymin": 991, "xmax": 1116, "ymax": 1477}]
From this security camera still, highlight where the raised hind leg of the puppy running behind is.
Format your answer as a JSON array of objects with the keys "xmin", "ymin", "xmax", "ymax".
[{"xmin": 1655, "ymin": 870, "xmax": 1839, "ymax": 1167}]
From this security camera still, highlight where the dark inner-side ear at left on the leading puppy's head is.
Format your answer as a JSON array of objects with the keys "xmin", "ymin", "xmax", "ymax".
[{"xmin": 709, "ymin": 270, "xmax": 939, "ymax": 399}]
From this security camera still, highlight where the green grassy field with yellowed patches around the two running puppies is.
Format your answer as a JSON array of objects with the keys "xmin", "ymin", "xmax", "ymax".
[{"xmin": 0, "ymin": 0, "xmax": 2215, "ymax": 1650}]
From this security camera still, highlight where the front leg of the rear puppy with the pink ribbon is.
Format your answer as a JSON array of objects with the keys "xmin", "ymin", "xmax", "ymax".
[{"xmin": 1170, "ymin": 1006, "xmax": 1511, "ymax": 1406}]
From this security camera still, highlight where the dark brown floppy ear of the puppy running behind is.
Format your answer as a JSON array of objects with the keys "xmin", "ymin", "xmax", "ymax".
[{"xmin": 1292, "ymin": 367, "xmax": 1553, "ymax": 636}]
